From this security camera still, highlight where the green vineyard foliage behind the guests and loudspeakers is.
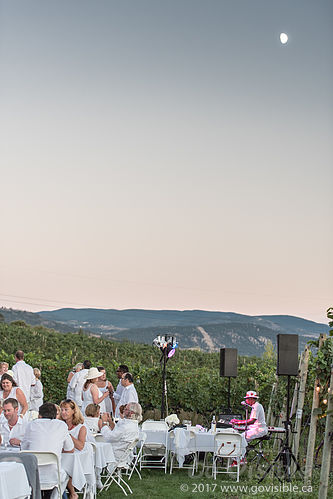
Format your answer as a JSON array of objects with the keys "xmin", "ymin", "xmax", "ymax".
[{"xmin": 0, "ymin": 322, "xmax": 333, "ymax": 428}]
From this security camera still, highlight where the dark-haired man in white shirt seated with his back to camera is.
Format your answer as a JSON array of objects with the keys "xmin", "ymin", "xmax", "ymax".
[{"xmin": 21, "ymin": 402, "xmax": 74, "ymax": 498}]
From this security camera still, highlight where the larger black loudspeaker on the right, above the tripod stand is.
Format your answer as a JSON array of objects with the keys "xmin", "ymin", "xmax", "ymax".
[{"xmin": 276, "ymin": 334, "xmax": 298, "ymax": 376}]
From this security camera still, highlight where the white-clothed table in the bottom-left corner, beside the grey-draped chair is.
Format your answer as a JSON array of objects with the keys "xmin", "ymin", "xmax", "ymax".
[{"xmin": 0, "ymin": 462, "xmax": 30, "ymax": 499}]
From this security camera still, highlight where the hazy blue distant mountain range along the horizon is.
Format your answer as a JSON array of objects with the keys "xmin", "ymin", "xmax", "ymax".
[{"xmin": 0, "ymin": 308, "xmax": 329, "ymax": 356}]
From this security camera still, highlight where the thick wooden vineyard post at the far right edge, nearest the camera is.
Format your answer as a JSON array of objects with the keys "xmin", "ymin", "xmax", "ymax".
[{"xmin": 318, "ymin": 363, "xmax": 333, "ymax": 499}]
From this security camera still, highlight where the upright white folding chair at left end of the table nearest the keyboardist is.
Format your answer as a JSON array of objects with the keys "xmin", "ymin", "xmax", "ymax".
[{"xmin": 140, "ymin": 421, "xmax": 169, "ymax": 473}]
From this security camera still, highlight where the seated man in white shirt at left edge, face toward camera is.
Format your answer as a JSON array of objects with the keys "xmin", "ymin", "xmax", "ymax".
[{"xmin": 0, "ymin": 398, "xmax": 28, "ymax": 447}]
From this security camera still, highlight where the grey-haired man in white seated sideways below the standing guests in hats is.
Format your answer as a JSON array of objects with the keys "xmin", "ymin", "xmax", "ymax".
[{"xmin": 99, "ymin": 402, "xmax": 142, "ymax": 462}]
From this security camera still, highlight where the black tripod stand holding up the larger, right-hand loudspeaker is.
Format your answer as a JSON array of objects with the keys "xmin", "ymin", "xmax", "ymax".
[{"xmin": 259, "ymin": 375, "xmax": 303, "ymax": 483}]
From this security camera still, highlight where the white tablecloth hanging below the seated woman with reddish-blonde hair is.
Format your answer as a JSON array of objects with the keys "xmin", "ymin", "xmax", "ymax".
[{"xmin": 61, "ymin": 444, "xmax": 96, "ymax": 497}]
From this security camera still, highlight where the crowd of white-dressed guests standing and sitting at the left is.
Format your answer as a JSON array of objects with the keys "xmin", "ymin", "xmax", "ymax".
[{"xmin": 0, "ymin": 350, "xmax": 142, "ymax": 499}]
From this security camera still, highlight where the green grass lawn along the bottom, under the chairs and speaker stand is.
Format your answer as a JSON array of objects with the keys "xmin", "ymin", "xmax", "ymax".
[{"xmin": 97, "ymin": 462, "xmax": 333, "ymax": 499}]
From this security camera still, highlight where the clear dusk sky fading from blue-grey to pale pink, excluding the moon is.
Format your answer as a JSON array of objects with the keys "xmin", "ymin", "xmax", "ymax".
[{"xmin": 0, "ymin": 0, "xmax": 333, "ymax": 323}]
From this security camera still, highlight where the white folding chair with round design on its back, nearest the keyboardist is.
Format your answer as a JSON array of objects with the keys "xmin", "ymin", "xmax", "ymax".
[{"xmin": 212, "ymin": 432, "xmax": 242, "ymax": 482}]
